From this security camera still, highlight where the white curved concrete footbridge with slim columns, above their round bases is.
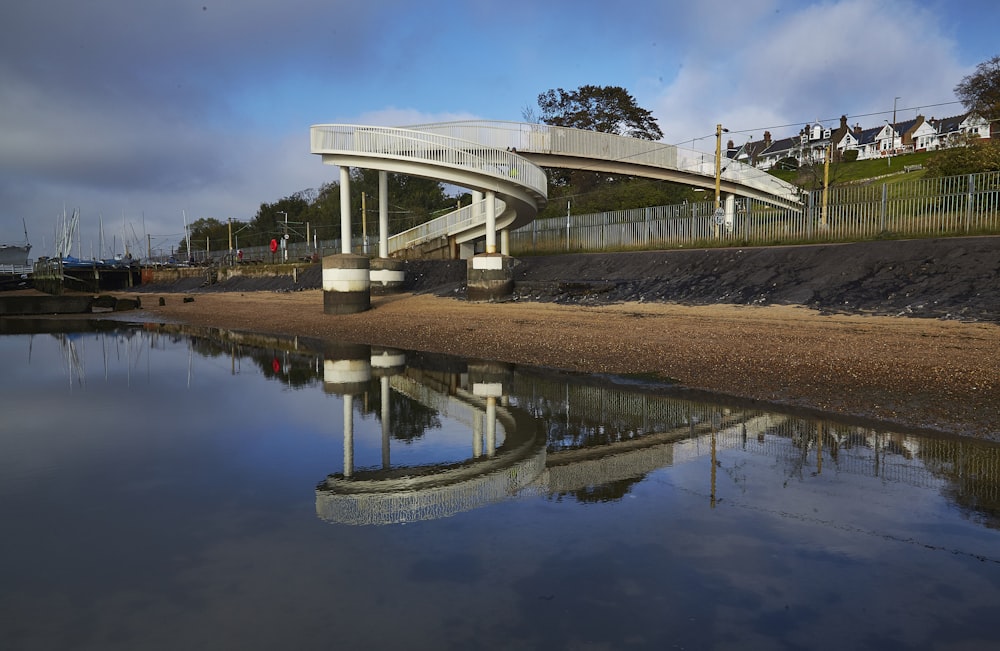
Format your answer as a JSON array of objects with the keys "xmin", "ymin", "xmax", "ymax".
[{"xmin": 310, "ymin": 120, "xmax": 802, "ymax": 257}]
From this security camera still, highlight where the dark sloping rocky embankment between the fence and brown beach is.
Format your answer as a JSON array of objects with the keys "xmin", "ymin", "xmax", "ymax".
[{"xmin": 140, "ymin": 237, "xmax": 1000, "ymax": 323}]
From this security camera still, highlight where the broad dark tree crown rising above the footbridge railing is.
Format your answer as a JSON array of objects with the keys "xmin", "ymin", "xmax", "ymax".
[{"xmin": 538, "ymin": 86, "xmax": 663, "ymax": 140}]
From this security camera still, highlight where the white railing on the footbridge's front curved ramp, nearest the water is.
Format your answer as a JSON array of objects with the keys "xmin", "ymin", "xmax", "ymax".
[{"xmin": 310, "ymin": 124, "xmax": 548, "ymax": 198}]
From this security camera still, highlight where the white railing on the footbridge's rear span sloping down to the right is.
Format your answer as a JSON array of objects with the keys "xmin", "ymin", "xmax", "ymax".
[{"xmin": 409, "ymin": 120, "xmax": 801, "ymax": 202}]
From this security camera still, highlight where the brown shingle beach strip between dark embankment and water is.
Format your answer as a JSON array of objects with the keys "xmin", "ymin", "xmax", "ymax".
[{"xmin": 130, "ymin": 290, "xmax": 1000, "ymax": 440}]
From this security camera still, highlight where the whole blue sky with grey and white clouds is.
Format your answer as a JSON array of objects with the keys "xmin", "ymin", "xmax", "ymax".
[{"xmin": 0, "ymin": 0, "xmax": 1000, "ymax": 257}]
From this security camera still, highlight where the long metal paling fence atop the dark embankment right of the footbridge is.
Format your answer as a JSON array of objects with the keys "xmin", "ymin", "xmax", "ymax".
[{"xmin": 510, "ymin": 172, "xmax": 1000, "ymax": 255}]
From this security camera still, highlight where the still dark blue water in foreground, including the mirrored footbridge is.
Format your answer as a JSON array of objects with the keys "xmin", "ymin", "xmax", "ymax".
[{"xmin": 0, "ymin": 321, "xmax": 1000, "ymax": 650}]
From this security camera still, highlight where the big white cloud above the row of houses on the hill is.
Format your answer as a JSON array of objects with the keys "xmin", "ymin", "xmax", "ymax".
[{"xmin": 653, "ymin": 0, "xmax": 964, "ymax": 149}]
